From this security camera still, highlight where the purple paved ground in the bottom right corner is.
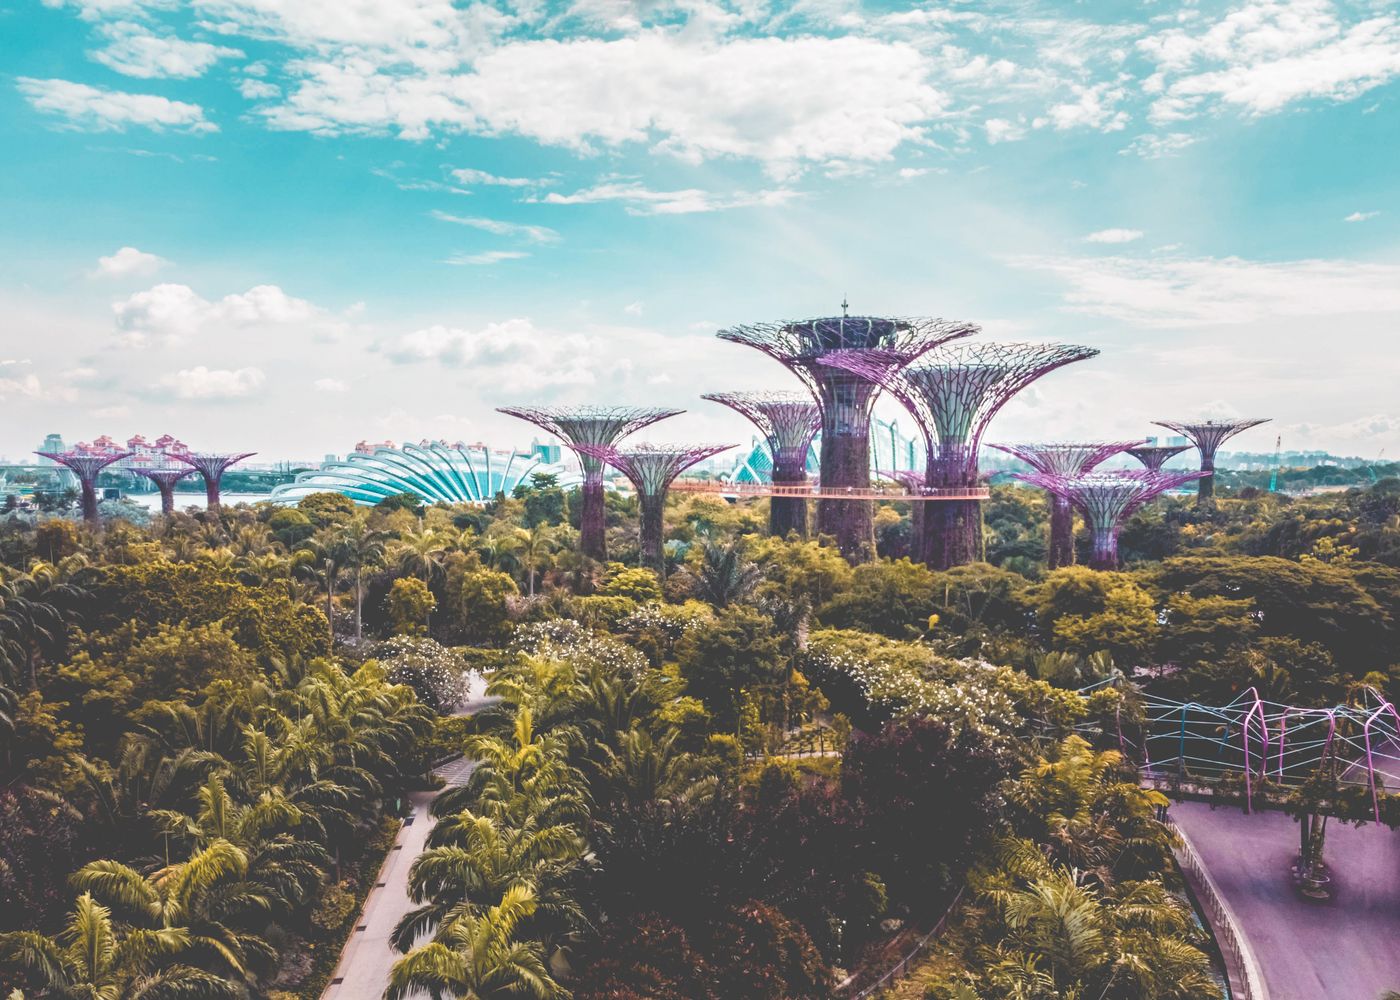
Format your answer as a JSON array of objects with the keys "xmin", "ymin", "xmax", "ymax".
[{"xmin": 1172, "ymin": 803, "xmax": 1400, "ymax": 1000}]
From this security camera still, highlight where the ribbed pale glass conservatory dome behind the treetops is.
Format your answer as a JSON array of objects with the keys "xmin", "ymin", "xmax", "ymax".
[{"xmin": 272, "ymin": 441, "xmax": 580, "ymax": 506}]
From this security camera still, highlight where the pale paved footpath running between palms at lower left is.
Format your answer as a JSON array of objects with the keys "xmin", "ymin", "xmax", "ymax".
[{"xmin": 322, "ymin": 669, "xmax": 500, "ymax": 1000}]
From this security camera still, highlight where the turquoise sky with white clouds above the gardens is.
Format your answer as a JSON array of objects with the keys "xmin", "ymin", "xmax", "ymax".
[{"xmin": 0, "ymin": 0, "xmax": 1400, "ymax": 459}]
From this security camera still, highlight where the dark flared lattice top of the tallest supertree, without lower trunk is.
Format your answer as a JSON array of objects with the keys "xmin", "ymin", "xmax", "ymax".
[{"xmin": 718, "ymin": 317, "xmax": 980, "ymax": 434}]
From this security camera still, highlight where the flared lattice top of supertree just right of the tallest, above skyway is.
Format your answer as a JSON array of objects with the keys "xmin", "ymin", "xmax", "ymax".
[{"xmin": 826, "ymin": 340, "xmax": 1099, "ymax": 486}]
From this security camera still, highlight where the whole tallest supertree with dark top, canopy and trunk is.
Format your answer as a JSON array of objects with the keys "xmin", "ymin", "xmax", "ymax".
[{"xmin": 720, "ymin": 315, "xmax": 979, "ymax": 560}]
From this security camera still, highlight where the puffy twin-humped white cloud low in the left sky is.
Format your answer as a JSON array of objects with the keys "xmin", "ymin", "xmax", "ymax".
[{"xmin": 112, "ymin": 283, "xmax": 330, "ymax": 347}]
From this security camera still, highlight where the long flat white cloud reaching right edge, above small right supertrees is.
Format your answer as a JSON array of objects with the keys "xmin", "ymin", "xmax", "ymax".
[{"xmin": 1014, "ymin": 250, "xmax": 1400, "ymax": 328}]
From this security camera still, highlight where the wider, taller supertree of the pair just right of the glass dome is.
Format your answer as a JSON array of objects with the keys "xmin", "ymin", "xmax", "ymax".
[{"xmin": 497, "ymin": 406, "xmax": 685, "ymax": 560}]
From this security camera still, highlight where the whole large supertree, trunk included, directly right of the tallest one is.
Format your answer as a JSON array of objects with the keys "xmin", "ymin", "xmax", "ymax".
[{"xmin": 826, "ymin": 340, "xmax": 1099, "ymax": 560}]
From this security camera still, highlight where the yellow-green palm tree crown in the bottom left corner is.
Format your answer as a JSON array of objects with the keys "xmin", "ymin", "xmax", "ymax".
[{"xmin": 0, "ymin": 892, "xmax": 238, "ymax": 1000}]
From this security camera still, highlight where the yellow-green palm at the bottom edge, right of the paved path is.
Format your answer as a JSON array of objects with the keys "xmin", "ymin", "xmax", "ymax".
[{"xmin": 384, "ymin": 887, "xmax": 568, "ymax": 1000}]
